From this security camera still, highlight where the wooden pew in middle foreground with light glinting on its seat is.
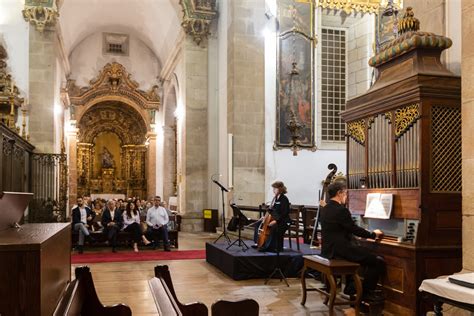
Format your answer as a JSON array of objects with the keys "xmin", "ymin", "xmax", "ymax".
[{"xmin": 148, "ymin": 265, "xmax": 208, "ymax": 316}]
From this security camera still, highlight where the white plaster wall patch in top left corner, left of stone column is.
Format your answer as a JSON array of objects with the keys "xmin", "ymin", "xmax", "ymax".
[{"xmin": 0, "ymin": 0, "xmax": 30, "ymax": 96}]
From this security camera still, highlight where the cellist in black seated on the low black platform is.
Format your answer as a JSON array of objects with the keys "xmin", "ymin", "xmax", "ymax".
[{"xmin": 252, "ymin": 181, "xmax": 290, "ymax": 252}]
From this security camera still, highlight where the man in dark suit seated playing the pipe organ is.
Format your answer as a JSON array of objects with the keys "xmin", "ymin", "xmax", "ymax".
[{"xmin": 320, "ymin": 182, "xmax": 385, "ymax": 300}]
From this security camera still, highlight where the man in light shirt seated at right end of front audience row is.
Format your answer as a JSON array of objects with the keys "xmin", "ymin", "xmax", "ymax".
[{"xmin": 146, "ymin": 196, "xmax": 171, "ymax": 251}]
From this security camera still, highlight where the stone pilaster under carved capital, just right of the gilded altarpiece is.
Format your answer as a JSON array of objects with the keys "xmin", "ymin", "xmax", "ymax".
[{"xmin": 179, "ymin": 35, "xmax": 209, "ymax": 231}]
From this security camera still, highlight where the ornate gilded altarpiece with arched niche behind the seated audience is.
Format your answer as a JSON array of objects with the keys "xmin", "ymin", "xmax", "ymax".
[{"xmin": 67, "ymin": 63, "xmax": 160, "ymax": 197}]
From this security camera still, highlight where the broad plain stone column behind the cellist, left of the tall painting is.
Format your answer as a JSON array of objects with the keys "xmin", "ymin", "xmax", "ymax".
[{"xmin": 227, "ymin": 0, "xmax": 265, "ymax": 205}]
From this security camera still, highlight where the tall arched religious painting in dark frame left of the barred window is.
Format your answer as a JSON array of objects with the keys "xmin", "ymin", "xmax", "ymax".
[{"xmin": 274, "ymin": 0, "xmax": 315, "ymax": 149}]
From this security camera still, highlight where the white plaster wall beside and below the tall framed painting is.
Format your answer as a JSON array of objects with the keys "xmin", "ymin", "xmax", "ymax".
[{"xmin": 265, "ymin": 3, "xmax": 346, "ymax": 205}]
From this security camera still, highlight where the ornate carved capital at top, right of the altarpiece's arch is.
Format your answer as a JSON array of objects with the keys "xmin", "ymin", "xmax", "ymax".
[{"xmin": 179, "ymin": 0, "xmax": 217, "ymax": 46}]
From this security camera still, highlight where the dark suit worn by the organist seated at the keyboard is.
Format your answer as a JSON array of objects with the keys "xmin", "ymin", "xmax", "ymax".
[{"xmin": 320, "ymin": 200, "xmax": 384, "ymax": 294}]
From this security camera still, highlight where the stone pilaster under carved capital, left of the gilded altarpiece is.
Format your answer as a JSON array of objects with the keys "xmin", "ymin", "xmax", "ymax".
[{"xmin": 29, "ymin": 27, "xmax": 59, "ymax": 153}]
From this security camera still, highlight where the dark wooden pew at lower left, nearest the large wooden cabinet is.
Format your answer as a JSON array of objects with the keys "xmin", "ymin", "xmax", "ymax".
[{"xmin": 53, "ymin": 267, "xmax": 132, "ymax": 316}]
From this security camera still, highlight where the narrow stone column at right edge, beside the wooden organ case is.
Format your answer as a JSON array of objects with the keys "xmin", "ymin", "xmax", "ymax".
[{"xmin": 461, "ymin": 0, "xmax": 474, "ymax": 271}]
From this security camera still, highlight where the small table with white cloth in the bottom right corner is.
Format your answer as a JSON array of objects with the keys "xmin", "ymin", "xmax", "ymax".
[{"xmin": 418, "ymin": 278, "xmax": 474, "ymax": 316}]
